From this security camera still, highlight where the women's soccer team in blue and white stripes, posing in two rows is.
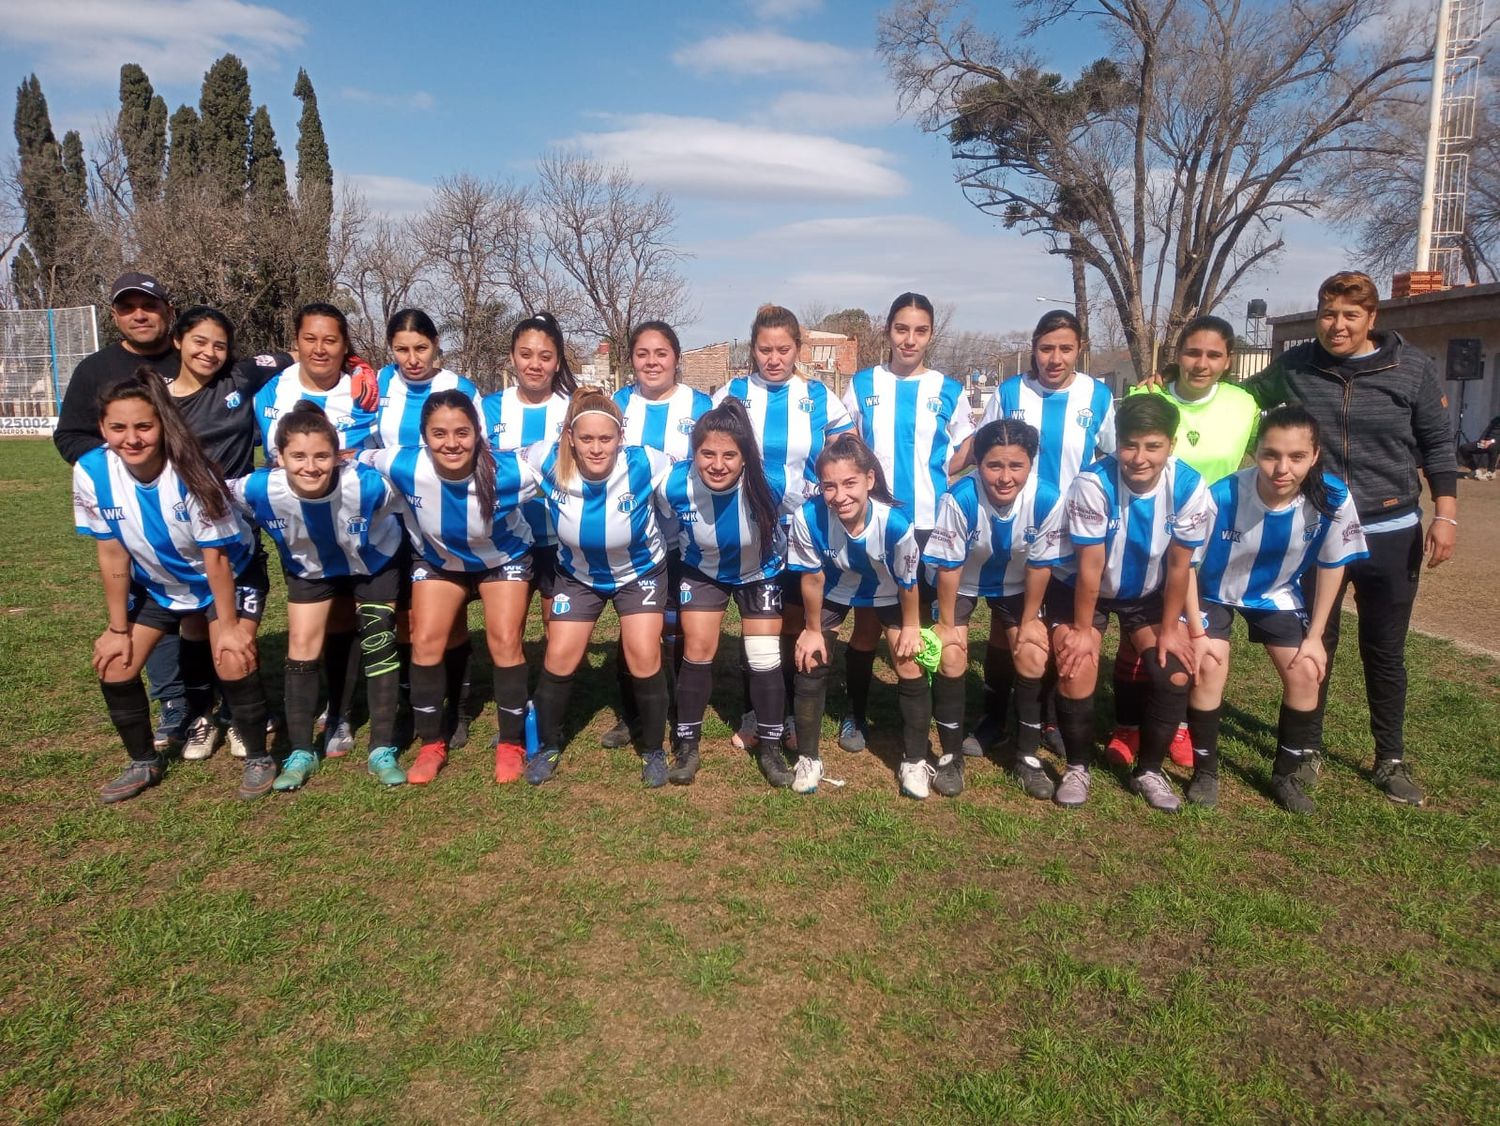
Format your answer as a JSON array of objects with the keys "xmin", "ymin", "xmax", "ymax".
[{"xmin": 74, "ymin": 279, "xmax": 1452, "ymax": 813}]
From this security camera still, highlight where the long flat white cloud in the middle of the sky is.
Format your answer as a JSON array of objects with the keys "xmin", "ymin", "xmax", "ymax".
[{"xmin": 566, "ymin": 114, "xmax": 908, "ymax": 202}]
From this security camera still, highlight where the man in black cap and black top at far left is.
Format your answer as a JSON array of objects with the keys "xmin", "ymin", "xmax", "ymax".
[{"xmin": 53, "ymin": 270, "xmax": 177, "ymax": 465}]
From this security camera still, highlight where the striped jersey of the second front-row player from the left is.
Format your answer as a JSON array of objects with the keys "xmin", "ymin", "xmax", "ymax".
[{"xmin": 230, "ymin": 462, "xmax": 407, "ymax": 579}]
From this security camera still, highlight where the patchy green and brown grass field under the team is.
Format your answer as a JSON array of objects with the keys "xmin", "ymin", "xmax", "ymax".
[{"xmin": 0, "ymin": 441, "xmax": 1500, "ymax": 1123}]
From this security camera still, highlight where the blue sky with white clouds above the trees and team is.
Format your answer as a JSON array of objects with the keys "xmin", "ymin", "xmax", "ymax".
[{"xmin": 0, "ymin": 0, "xmax": 1341, "ymax": 346}]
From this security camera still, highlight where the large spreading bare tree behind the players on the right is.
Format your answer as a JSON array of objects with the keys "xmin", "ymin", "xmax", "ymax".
[{"xmin": 879, "ymin": 0, "xmax": 1431, "ymax": 379}]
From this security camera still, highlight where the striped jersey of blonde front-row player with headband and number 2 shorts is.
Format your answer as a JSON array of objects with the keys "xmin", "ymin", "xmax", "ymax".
[{"xmin": 531, "ymin": 445, "xmax": 672, "ymax": 594}]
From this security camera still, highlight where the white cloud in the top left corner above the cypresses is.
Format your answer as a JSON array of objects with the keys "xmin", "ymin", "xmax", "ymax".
[{"xmin": 0, "ymin": 0, "xmax": 308, "ymax": 84}]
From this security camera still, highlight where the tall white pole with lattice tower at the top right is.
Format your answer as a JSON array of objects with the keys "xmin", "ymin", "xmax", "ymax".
[{"xmin": 1416, "ymin": 0, "xmax": 1485, "ymax": 283}]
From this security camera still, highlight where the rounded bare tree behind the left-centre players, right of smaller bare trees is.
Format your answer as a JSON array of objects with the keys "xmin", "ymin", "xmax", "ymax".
[{"xmin": 534, "ymin": 151, "xmax": 696, "ymax": 364}]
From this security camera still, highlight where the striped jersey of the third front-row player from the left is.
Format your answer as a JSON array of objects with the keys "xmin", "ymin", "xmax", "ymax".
[{"xmin": 360, "ymin": 445, "xmax": 540, "ymax": 571}]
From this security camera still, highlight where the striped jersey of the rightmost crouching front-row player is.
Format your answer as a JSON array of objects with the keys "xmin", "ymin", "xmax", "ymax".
[{"xmin": 1199, "ymin": 465, "xmax": 1370, "ymax": 610}]
